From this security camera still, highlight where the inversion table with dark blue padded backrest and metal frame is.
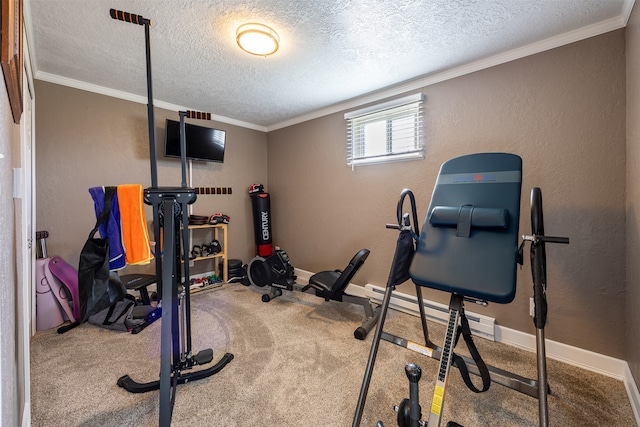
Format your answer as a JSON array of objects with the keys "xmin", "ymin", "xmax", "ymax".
[{"xmin": 352, "ymin": 153, "xmax": 569, "ymax": 427}]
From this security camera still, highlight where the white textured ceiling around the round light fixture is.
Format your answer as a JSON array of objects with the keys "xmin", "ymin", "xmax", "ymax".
[{"xmin": 24, "ymin": 0, "xmax": 634, "ymax": 129}]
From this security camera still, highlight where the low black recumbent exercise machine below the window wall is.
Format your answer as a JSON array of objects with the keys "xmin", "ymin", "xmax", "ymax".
[{"xmin": 247, "ymin": 249, "xmax": 380, "ymax": 340}]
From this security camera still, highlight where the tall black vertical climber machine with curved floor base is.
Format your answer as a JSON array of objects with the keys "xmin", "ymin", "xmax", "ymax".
[{"xmin": 109, "ymin": 9, "xmax": 233, "ymax": 427}]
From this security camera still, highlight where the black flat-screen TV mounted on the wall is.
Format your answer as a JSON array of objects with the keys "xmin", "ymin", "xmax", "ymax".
[{"xmin": 164, "ymin": 119, "xmax": 226, "ymax": 163}]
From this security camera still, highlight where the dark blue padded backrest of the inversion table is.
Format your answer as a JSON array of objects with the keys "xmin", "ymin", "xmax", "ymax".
[{"xmin": 409, "ymin": 153, "xmax": 522, "ymax": 304}]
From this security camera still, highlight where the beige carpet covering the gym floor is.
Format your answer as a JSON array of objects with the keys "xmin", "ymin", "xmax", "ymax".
[{"xmin": 31, "ymin": 284, "xmax": 636, "ymax": 427}]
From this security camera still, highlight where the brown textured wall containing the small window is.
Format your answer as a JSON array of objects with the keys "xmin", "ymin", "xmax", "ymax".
[{"xmin": 268, "ymin": 31, "xmax": 626, "ymax": 359}]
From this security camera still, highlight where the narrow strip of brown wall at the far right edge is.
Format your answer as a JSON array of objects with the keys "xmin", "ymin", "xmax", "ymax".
[{"xmin": 625, "ymin": 5, "xmax": 640, "ymax": 392}]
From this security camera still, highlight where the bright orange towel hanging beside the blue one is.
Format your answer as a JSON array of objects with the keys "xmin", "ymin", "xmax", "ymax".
[{"xmin": 118, "ymin": 184, "xmax": 153, "ymax": 264}]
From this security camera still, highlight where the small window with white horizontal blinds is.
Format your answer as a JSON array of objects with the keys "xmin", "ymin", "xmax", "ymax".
[{"xmin": 344, "ymin": 93, "xmax": 424, "ymax": 167}]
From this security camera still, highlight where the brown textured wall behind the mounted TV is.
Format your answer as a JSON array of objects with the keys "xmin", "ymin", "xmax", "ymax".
[{"xmin": 36, "ymin": 81, "xmax": 267, "ymax": 273}]
